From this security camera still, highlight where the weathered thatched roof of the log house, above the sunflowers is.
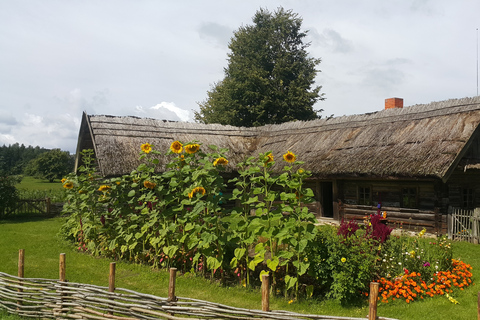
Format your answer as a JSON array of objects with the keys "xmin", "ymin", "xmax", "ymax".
[{"xmin": 77, "ymin": 97, "xmax": 480, "ymax": 180}]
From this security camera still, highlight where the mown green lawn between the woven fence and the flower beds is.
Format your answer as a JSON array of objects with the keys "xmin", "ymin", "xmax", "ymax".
[{"xmin": 0, "ymin": 218, "xmax": 480, "ymax": 320}]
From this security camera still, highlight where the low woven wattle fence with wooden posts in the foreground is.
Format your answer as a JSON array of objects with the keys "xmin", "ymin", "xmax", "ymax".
[{"xmin": 0, "ymin": 249, "xmax": 402, "ymax": 320}]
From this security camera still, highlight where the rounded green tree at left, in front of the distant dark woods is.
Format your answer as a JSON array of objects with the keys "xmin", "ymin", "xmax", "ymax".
[{"xmin": 25, "ymin": 149, "xmax": 75, "ymax": 182}]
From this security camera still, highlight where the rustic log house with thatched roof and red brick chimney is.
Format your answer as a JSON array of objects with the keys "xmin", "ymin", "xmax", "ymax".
[{"xmin": 77, "ymin": 97, "xmax": 480, "ymax": 233}]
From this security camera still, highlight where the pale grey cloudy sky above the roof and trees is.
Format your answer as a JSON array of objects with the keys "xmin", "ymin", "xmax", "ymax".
[{"xmin": 0, "ymin": 0, "xmax": 480, "ymax": 152}]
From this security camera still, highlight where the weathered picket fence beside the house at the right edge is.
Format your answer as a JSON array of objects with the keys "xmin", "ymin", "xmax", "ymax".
[{"xmin": 448, "ymin": 208, "xmax": 480, "ymax": 244}]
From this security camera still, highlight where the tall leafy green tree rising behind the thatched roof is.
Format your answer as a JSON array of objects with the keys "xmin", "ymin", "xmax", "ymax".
[{"xmin": 195, "ymin": 8, "xmax": 323, "ymax": 127}]
